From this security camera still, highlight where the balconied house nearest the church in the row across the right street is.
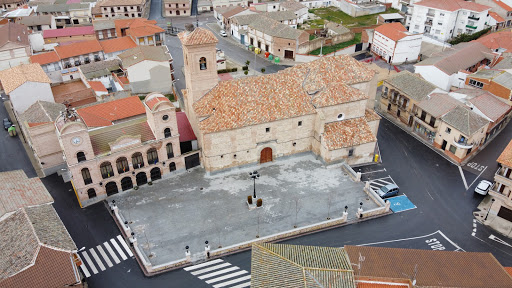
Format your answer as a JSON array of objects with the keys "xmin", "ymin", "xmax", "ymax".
[{"xmin": 380, "ymin": 70, "xmax": 437, "ymax": 127}]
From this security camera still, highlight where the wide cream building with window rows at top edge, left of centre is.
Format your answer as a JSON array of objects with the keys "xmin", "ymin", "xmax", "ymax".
[{"xmin": 94, "ymin": 0, "xmax": 149, "ymax": 19}]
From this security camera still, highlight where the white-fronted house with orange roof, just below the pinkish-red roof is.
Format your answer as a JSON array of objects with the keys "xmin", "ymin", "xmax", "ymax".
[{"xmin": 54, "ymin": 39, "xmax": 105, "ymax": 68}]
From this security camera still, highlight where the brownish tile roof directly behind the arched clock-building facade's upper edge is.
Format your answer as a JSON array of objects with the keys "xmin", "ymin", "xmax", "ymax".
[{"xmin": 89, "ymin": 117, "xmax": 155, "ymax": 155}]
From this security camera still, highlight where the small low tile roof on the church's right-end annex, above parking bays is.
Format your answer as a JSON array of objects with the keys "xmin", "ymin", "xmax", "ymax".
[{"xmin": 324, "ymin": 117, "xmax": 377, "ymax": 150}]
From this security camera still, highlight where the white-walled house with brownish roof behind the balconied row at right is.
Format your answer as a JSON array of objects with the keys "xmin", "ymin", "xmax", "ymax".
[{"xmin": 414, "ymin": 41, "xmax": 497, "ymax": 91}]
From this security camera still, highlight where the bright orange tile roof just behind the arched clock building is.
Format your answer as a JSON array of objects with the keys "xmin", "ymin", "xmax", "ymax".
[{"xmin": 76, "ymin": 96, "xmax": 146, "ymax": 128}]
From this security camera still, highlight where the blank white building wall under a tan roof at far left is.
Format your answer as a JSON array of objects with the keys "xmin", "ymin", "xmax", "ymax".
[{"xmin": 9, "ymin": 82, "xmax": 55, "ymax": 113}]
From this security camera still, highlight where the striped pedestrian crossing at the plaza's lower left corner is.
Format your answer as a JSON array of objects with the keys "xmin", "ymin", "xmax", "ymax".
[{"xmin": 79, "ymin": 235, "xmax": 133, "ymax": 278}]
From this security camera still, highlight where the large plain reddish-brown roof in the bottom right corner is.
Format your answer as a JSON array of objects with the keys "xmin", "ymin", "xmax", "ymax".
[{"xmin": 345, "ymin": 246, "xmax": 512, "ymax": 288}]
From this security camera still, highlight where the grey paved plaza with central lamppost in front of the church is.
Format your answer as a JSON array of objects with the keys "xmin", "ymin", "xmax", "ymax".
[{"xmin": 111, "ymin": 153, "xmax": 378, "ymax": 266}]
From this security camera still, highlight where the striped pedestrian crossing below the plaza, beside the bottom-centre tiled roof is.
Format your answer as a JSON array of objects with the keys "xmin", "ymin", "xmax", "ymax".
[{"xmin": 183, "ymin": 259, "xmax": 251, "ymax": 288}]
